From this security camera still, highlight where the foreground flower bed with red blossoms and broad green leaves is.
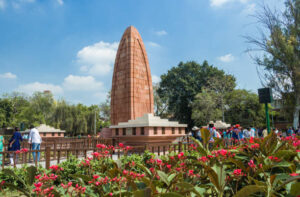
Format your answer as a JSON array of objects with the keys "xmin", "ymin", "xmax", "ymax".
[{"xmin": 0, "ymin": 131, "xmax": 300, "ymax": 197}]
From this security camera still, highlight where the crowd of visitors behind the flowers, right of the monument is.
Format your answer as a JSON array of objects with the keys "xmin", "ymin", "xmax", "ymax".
[{"xmin": 191, "ymin": 121, "xmax": 300, "ymax": 145}]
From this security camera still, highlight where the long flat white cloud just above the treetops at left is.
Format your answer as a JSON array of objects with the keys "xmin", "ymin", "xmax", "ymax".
[{"xmin": 17, "ymin": 82, "xmax": 63, "ymax": 95}]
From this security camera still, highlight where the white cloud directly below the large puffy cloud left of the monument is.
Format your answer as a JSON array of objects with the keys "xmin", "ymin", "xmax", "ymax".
[{"xmin": 63, "ymin": 75, "xmax": 103, "ymax": 91}]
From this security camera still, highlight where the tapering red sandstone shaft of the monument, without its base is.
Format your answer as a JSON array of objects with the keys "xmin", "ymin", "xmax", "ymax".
[{"xmin": 111, "ymin": 26, "xmax": 153, "ymax": 125}]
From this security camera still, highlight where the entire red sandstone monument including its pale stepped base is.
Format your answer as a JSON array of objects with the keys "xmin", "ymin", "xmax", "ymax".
[{"xmin": 109, "ymin": 26, "xmax": 187, "ymax": 145}]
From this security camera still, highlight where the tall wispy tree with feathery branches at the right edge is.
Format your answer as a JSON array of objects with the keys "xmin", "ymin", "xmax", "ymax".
[{"xmin": 246, "ymin": 0, "xmax": 300, "ymax": 127}]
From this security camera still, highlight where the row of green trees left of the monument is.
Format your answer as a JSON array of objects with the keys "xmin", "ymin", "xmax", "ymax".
[{"xmin": 0, "ymin": 92, "xmax": 109, "ymax": 135}]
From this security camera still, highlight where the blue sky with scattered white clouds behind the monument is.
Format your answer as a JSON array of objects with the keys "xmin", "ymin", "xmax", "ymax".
[{"xmin": 0, "ymin": 0, "xmax": 284, "ymax": 105}]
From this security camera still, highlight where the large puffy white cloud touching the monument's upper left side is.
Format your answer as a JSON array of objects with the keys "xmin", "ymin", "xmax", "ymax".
[{"xmin": 77, "ymin": 41, "xmax": 119, "ymax": 76}]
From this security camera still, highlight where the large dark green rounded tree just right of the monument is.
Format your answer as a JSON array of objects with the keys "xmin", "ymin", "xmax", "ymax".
[{"xmin": 158, "ymin": 61, "xmax": 235, "ymax": 128}]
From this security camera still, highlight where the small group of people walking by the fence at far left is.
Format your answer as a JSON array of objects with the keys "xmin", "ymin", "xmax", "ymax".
[{"xmin": 0, "ymin": 125, "xmax": 42, "ymax": 165}]
